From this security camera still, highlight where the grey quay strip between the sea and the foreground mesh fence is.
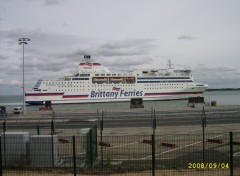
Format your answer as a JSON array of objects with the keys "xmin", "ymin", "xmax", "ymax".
[{"xmin": 0, "ymin": 104, "xmax": 240, "ymax": 133}]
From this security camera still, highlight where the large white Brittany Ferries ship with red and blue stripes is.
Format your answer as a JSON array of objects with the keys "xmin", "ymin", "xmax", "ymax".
[{"xmin": 25, "ymin": 55, "xmax": 208, "ymax": 105}]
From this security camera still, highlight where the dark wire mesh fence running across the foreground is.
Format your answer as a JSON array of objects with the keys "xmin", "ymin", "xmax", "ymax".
[{"xmin": 0, "ymin": 130, "xmax": 240, "ymax": 175}]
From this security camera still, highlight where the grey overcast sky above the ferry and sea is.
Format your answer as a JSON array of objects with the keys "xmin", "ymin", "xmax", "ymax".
[{"xmin": 0, "ymin": 0, "xmax": 240, "ymax": 95}]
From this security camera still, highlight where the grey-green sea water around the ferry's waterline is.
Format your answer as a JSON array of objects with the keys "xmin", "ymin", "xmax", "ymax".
[{"xmin": 0, "ymin": 90, "xmax": 240, "ymax": 111}]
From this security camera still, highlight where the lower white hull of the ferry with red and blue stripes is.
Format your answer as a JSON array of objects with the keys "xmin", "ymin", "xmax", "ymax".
[{"xmin": 26, "ymin": 86, "xmax": 206, "ymax": 105}]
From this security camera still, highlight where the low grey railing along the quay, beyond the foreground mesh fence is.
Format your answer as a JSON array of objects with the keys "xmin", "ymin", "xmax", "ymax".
[{"xmin": 0, "ymin": 108, "xmax": 240, "ymax": 121}]
